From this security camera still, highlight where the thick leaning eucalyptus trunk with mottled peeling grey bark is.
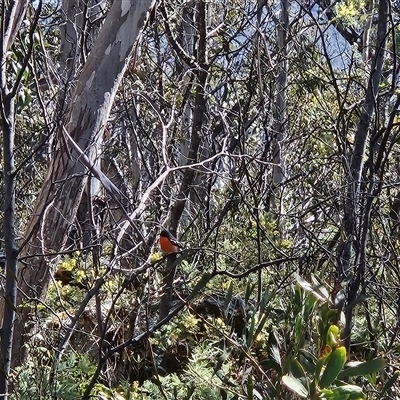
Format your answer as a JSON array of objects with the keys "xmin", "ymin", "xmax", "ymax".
[{"xmin": 9, "ymin": 0, "xmax": 152, "ymax": 365}]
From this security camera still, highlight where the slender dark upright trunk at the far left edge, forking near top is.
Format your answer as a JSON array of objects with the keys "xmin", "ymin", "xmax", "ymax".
[{"xmin": 0, "ymin": 1, "xmax": 31, "ymax": 400}]
